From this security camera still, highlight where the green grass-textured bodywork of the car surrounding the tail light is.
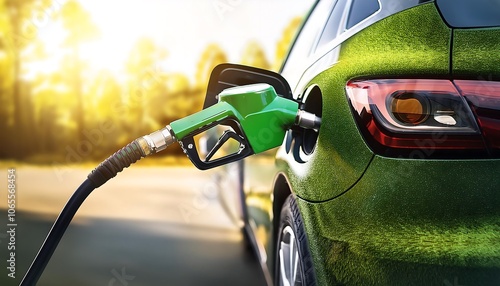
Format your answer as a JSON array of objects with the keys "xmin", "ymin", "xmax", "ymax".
[{"xmin": 240, "ymin": 2, "xmax": 500, "ymax": 285}]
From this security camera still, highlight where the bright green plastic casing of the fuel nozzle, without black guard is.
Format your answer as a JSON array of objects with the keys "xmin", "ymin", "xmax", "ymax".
[{"xmin": 170, "ymin": 84, "xmax": 298, "ymax": 150}]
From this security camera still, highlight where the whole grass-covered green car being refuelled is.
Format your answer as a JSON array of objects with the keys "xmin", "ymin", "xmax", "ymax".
[{"xmin": 204, "ymin": 0, "xmax": 500, "ymax": 286}]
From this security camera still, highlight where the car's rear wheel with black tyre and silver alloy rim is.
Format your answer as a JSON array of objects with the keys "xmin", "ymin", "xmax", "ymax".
[{"xmin": 274, "ymin": 195, "xmax": 316, "ymax": 286}]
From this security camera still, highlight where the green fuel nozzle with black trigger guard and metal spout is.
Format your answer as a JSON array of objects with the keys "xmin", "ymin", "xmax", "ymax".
[{"xmin": 170, "ymin": 83, "xmax": 321, "ymax": 169}]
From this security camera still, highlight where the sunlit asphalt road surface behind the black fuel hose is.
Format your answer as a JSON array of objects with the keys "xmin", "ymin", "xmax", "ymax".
[{"xmin": 0, "ymin": 167, "xmax": 265, "ymax": 286}]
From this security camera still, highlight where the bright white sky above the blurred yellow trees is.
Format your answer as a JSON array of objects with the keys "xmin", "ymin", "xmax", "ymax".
[{"xmin": 34, "ymin": 0, "xmax": 313, "ymax": 82}]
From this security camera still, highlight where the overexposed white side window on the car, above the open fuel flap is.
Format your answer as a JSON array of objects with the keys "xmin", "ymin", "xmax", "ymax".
[{"xmin": 281, "ymin": 1, "xmax": 335, "ymax": 89}]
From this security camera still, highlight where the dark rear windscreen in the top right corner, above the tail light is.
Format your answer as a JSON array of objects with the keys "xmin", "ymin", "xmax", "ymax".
[{"xmin": 436, "ymin": 0, "xmax": 500, "ymax": 28}]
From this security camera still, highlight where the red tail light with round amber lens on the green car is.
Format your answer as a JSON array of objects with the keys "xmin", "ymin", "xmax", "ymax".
[{"xmin": 346, "ymin": 79, "xmax": 500, "ymax": 158}]
